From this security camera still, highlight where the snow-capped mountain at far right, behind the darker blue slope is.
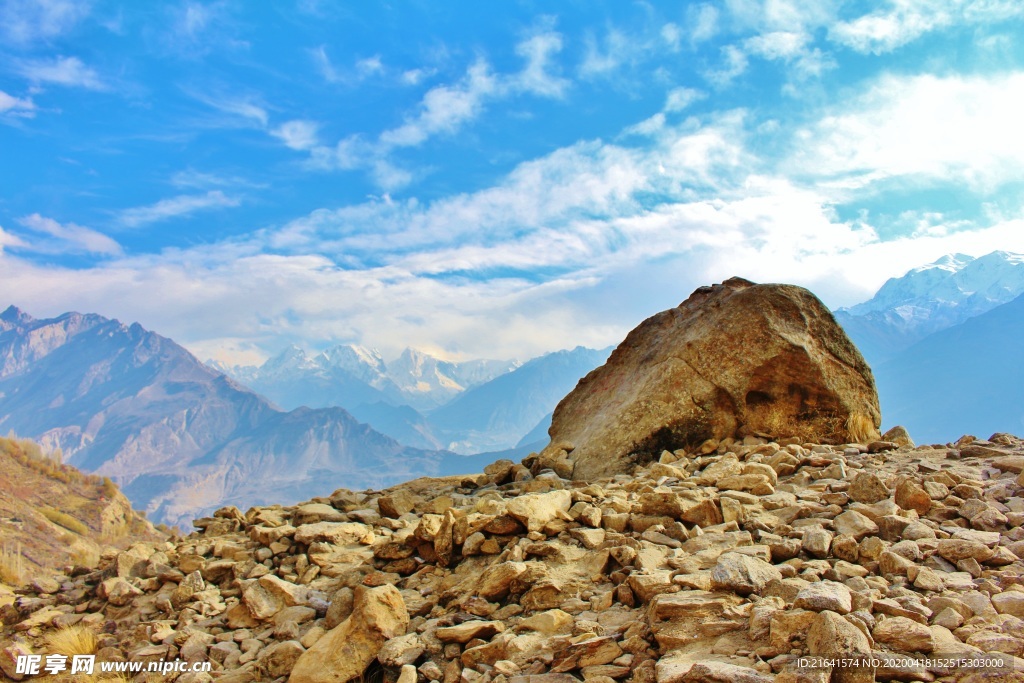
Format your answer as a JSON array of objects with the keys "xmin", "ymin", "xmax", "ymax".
[{"xmin": 836, "ymin": 251, "xmax": 1024, "ymax": 366}]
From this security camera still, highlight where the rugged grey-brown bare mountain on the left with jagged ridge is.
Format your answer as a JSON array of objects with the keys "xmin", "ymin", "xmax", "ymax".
[{"xmin": 0, "ymin": 306, "xmax": 463, "ymax": 525}]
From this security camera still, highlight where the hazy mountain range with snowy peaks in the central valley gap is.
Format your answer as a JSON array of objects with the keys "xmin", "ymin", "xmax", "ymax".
[{"xmin": 210, "ymin": 345, "xmax": 611, "ymax": 455}]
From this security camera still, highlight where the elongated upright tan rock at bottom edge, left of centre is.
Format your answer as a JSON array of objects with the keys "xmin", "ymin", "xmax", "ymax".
[{"xmin": 288, "ymin": 585, "xmax": 409, "ymax": 683}]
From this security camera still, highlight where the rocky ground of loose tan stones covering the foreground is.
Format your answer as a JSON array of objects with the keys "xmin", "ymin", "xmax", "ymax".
[{"xmin": 0, "ymin": 432, "xmax": 1024, "ymax": 683}]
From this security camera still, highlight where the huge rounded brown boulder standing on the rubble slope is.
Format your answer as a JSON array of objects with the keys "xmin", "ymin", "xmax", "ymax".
[{"xmin": 537, "ymin": 278, "xmax": 881, "ymax": 479}]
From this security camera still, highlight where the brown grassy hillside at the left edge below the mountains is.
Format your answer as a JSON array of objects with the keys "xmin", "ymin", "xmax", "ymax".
[{"xmin": 0, "ymin": 437, "xmax": 159, "ymax": 585}]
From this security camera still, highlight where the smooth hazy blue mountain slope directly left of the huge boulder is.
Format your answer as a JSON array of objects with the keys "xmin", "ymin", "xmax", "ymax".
[{"xmin": 428, "ymin": 346, "xmax": 611, "ymax": 453}]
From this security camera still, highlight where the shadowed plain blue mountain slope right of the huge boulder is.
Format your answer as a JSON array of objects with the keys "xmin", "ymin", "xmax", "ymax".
[{"xmin": 873, "ymin": 296, "xmax": 1024, "ymax": 443}]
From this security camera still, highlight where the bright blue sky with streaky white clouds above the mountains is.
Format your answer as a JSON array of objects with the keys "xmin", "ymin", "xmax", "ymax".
[{"xmin": 0, "ymin": 0, "xmax": 1024, "ymax": 361}]
